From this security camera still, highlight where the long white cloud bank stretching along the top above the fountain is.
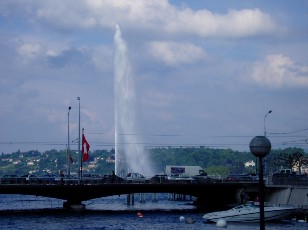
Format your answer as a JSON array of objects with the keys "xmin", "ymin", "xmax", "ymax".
[{"xmin": 0, "ymin": 0, "xmax": 276, "ymax": 37}]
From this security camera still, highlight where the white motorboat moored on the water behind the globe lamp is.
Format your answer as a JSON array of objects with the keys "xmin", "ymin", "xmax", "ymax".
[{"xmin": 203, "ymin": 204, "xmax": 295, "ymax": 222}]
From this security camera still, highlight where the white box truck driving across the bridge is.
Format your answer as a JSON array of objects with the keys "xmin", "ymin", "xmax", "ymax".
[{"xmin": 165, "ymin": 165, "xmax": 207, "ymax": 177}]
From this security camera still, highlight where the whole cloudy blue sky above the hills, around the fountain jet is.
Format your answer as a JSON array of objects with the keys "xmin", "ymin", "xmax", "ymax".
[{"xmin": 0, "ymin": 0, "xmax": 308, "ymax": 154}]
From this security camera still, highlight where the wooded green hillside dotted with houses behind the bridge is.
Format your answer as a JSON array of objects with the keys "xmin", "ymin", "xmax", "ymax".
[{"xmin": 0, "ymin": 146, "xmax": 307, "ymax": 177}]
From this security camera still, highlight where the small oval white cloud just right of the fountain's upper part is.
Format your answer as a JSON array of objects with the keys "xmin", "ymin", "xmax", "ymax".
[{"xmin": 149, "ymin": 41, "xmax": 206, "ymax": 66}]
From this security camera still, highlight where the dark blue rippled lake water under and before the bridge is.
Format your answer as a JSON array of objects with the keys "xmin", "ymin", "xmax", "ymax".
[{"xmin": 0, "ymin": 194, "xmax": 308, "ymax": 230}]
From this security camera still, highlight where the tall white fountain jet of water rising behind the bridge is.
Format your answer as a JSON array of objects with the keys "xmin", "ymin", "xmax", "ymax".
[{"xmin": 114, "ymin": 25, "xmax": 153, "ymax": 177}]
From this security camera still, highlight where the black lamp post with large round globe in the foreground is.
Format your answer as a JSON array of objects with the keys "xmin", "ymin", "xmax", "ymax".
[{"xmin": 249, "ymin": 136, "xmax": 272, "ymax": 230}]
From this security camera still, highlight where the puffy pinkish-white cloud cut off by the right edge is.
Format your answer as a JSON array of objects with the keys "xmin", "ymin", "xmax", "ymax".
[{"xmin": 251, "ymin": 54, "xmax": 308, "ymax": 88}]
